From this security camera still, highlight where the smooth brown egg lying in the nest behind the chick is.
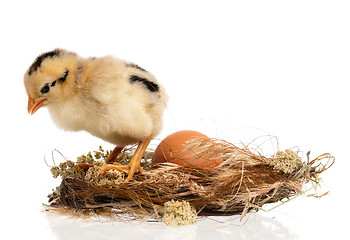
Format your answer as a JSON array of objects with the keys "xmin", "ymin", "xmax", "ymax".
[{"xmin": 152, "ymin": 130, "xmax": 222, "ymax": 170}]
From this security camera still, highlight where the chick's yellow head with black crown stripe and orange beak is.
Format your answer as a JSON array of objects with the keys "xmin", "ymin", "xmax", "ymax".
[{"xmin": 24, "ymin": 49, "xmax": 79, "ymax": 114}]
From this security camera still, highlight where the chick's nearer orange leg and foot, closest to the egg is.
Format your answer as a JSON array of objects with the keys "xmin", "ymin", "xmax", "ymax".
[{"xmin": 99, "ymin": 136, "xmax": 152, "ymax": 183}]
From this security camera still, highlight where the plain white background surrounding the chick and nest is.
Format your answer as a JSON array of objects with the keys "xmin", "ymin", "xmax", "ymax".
[{"xmin": 0, "ymin": 0, "xmax": 350, "ymax": 239}]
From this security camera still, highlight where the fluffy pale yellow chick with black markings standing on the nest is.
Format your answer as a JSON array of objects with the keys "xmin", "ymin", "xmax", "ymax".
[{"xmin": 24, "ymin": 49, "xmax": 168, "ymax": 182}]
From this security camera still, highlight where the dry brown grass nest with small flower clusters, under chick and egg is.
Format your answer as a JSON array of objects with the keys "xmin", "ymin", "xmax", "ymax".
[{"xmin": 48, "ymin": 139, "xmax": 334, "ymax": 224}]
